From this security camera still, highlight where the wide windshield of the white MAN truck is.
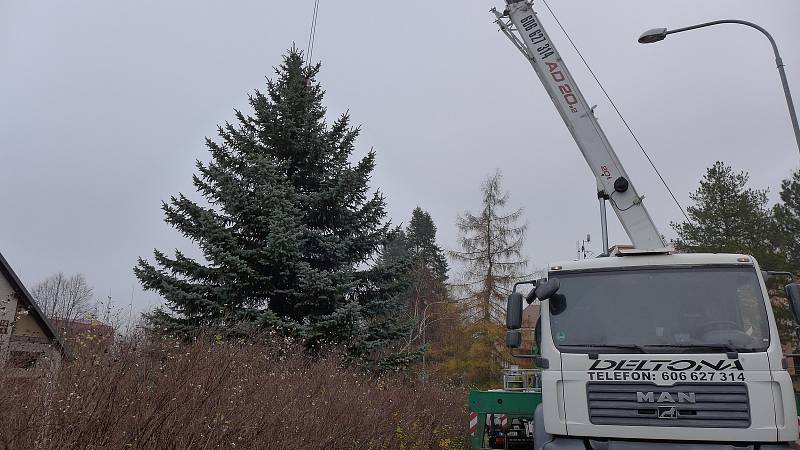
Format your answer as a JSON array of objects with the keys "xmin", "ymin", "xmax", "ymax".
[{"xmin": 550, "ymin": 267, "xmax": 769, "ymax": 353}]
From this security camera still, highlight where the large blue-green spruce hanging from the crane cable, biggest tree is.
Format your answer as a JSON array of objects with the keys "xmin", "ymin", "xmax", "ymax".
[{"xmin": 134, "ymin": 49, "xmax": 408, "ymax": 370}]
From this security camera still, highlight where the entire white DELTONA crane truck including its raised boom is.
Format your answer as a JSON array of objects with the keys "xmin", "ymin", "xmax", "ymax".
[{"xmin": 470, "ymin": 0, "xmax": 800, "ymax": 450}]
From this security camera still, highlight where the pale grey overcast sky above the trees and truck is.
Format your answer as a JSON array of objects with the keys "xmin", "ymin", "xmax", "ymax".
[{"xmin": 0, "ymin": 0, "xmax": 800, "ymax": 311}]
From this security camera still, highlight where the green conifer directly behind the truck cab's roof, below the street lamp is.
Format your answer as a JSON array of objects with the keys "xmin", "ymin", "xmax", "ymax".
[{"xmin": 672, "ymin": 161, "xmax": 782, "ymax": 268}]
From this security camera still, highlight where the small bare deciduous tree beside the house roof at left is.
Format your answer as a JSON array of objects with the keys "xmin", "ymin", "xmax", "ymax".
[{"xmin": 31, "ymin": 272, "xmax": 94, "ymax": 321}]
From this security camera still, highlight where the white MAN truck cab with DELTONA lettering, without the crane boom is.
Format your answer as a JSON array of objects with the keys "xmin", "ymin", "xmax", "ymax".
[{"xmin": 529, "ymin": 253, "xmax": 798, "ymax": 450}]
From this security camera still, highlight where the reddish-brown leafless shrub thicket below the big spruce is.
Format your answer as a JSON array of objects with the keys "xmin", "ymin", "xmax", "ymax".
[{"xmin": 0, "ymin": 339, "xmax": 466, "ymax": 450}]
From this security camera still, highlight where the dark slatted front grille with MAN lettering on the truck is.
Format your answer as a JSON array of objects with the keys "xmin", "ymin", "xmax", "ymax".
[{"xmin": 586, "ymin": 383, "xmax": 750, "ymax": 428}]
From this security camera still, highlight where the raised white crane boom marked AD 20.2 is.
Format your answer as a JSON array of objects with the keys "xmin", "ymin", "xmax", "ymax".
[{"xmin": 492, "ymin": 0, "xmax": 665, "ymax": 250}]
